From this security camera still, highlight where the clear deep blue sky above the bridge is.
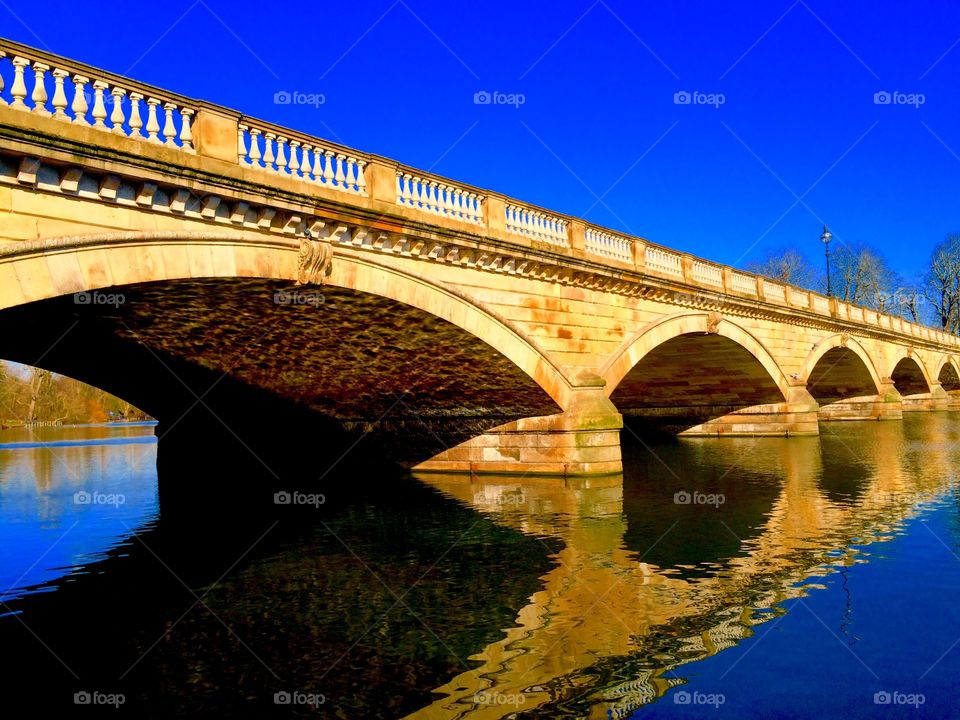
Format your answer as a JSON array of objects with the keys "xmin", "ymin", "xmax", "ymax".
[{"xmin": 7, "ymin": 0, "xmax": 960, "ymax": 274}]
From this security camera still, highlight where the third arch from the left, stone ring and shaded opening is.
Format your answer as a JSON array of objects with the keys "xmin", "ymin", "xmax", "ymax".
[{"xmin": 798, "ymin": 333, "xmax": 882, "ymax": 402}]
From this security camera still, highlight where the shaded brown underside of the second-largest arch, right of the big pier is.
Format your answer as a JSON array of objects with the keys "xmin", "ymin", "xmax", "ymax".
[{"xmin": 610, "ymin": 333, "xmax": 786, "ymax": 434}]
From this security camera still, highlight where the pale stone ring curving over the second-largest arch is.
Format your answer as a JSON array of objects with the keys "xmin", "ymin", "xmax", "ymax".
[{"xmin": 600, "ymin": 313, "xmax": 790, "ymax": 397}]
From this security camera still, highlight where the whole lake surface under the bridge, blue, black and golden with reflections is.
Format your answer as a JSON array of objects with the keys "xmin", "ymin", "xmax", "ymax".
[{"xmin": 0, "ymin": 413, "xmax": 960, "ymax": 720}]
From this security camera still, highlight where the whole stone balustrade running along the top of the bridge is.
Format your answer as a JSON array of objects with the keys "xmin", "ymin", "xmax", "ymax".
[{"xmin": 0, "ymin": 39, "xmax": 960, "ymax": 346}]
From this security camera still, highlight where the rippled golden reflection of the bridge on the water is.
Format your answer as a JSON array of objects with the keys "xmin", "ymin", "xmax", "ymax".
[{"xmin": 408, "ymin": 413, "xmax": 960, "ymax": 720}]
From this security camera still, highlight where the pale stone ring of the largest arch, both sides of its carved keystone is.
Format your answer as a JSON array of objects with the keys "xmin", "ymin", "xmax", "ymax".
[{"xmin": 0, "ymin": 232, "xmax": 571, "ymax": 408}]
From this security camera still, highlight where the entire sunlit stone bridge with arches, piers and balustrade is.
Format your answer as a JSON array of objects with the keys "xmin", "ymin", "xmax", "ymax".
[{"xmin": 0, "ymin": 40, "xmax": 960, "ymax": 476}]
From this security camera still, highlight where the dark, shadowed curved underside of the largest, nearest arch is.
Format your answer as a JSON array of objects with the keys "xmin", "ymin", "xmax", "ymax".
[{"xmin": 0, "ymin": 278, "xmax": 560, "ymax": 462}]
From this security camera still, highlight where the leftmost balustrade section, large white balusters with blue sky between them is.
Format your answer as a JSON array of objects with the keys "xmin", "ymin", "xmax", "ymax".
[{"xmin": 0, "ymin": 41, "xmax": 197, "ymax": 153}]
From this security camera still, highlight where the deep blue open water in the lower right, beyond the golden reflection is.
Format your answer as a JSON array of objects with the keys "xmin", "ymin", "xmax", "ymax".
[{"xmin": 630, "ymin": 500, "xmax": 960, "ymax": 719}]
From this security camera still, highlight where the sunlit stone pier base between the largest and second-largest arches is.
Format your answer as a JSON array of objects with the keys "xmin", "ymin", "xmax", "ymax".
[{"xmin": 414, "ymin": 378, "xmax": 623, "ymax": 477}]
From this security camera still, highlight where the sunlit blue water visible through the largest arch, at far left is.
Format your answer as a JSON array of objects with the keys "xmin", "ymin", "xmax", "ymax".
[{"xmin": 0, "ymin": 423, "xmax": 159, "ymax": 609}]
